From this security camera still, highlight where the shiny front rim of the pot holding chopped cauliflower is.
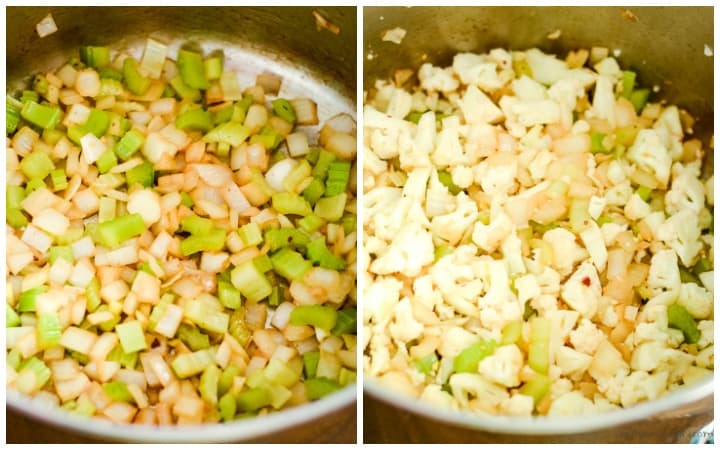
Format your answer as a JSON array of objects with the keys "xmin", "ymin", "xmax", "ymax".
[{"xmin": 363, "ymin": 376, "xmax": 713, "ymax": 435}]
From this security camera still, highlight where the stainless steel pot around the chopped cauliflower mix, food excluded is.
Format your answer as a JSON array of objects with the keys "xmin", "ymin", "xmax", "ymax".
[{"xmin": 363, "ymin": 7, "xmax": 713, "ymax": 443}]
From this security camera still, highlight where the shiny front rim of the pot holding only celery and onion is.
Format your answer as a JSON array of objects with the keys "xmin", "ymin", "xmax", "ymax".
[{"xmin": 7, "ymin": 384, "xmax": 357, "ymax": 443}]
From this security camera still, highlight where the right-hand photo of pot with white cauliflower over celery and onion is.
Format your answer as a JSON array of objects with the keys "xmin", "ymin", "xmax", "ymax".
[{"xmin": 360, "ymin": 6, "xmax": 714, "ymax": 443}]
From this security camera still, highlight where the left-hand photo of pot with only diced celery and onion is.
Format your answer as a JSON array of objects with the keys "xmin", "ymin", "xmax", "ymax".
[{"xmin": 5, "ymin": 6, "xmax": 357, "ymax": 443}]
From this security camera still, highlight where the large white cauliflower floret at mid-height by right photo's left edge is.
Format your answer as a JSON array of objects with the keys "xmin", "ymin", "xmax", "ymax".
[{"xmin": 370, "ymin": 223, "xmax": 435, "ymax": 277}]
